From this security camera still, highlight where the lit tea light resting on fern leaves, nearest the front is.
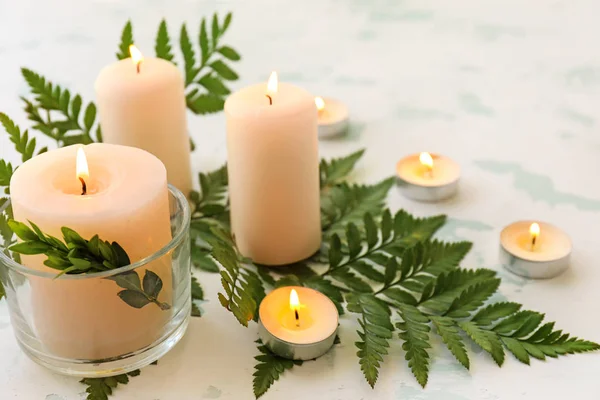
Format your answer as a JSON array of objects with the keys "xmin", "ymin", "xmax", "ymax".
[{"xmin": 258, "ymin": 286, "xmax": 339, "ymax": 360}]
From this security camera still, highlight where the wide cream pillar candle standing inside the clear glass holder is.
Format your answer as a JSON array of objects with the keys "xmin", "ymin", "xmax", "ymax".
[{"xmin": 10, "ymin": 144, "xmax": 173, "ymax": 359}]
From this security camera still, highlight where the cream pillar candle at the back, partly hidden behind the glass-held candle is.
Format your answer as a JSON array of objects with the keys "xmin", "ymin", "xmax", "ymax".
[{"xmin": 95, "ymin": 48, "xmax": 192, "ymax": 196}]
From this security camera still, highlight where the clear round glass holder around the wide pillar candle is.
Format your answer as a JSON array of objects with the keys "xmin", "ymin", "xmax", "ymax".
[{"xmin": 0, "ymin": 185, "xmax": 191, "ymax": 377}]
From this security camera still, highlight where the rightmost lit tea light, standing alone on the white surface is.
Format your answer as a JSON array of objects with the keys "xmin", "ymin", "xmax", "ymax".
[{"xmin": 500, "ymin": 221, "xmax": 572, "ymax": 278}]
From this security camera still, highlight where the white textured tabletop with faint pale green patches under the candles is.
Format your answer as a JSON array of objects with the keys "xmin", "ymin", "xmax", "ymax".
[{"xmin": 0, "ymin": 0, "xmax": 600, "ymax": 400}]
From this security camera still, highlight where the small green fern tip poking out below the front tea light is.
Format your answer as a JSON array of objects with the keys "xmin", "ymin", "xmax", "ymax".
[{"xmin": 252, "ymin": 345, "xmax": 302, "ymax": 399}]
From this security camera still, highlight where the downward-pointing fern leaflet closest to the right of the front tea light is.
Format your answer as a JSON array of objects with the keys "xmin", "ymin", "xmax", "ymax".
[{"xmin": 346, "ymin": 294, "xmax": 394, "ymax": 387}]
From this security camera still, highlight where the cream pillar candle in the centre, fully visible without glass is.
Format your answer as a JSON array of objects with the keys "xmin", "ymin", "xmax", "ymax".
[{"xmin": 225, "ymin": 74, "xmax": 321, "ymax": 265}]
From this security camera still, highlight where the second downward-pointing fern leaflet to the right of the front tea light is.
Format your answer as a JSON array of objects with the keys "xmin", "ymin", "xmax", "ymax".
[{"xmin": 396, "ymin": 304, "xmax": 431, "ymax": 387}]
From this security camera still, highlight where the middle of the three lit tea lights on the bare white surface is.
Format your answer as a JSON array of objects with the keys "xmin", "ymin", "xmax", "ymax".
[{"xmin": 396, "ymin": 152, "xmax": 460, "ymax": 201}]
